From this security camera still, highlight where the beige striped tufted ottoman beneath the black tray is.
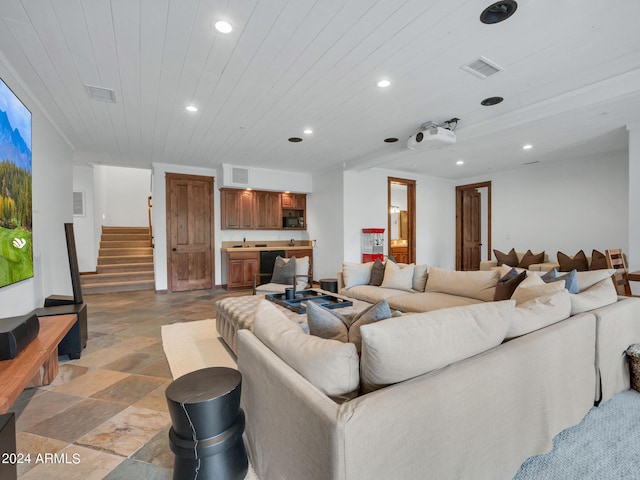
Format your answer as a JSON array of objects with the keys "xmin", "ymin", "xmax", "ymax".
[{"xmin": 214, "ymin": 289, "xmax": 371, "ymax": 355}]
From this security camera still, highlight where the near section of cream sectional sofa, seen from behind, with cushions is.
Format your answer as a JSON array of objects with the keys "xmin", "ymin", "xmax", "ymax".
[{"xmin": 237, "ymin": 264, "xmax": 640, "ymax": 480}]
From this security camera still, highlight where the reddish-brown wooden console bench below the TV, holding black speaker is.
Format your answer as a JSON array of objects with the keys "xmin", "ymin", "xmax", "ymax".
[{"xmin": 0, "ymin": 314, "xmax": 78, "ymax": 414}]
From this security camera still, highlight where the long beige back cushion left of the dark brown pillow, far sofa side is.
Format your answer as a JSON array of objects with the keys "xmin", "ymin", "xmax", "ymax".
[{"xmin": 425, "ymin": 267, "xmax": 499, "ymax": 302}]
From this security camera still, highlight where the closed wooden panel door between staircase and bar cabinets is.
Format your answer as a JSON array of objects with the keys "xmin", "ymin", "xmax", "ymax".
[{"xmin": 166, "ymin": 173, "xmax": 214, "ymax": 292}]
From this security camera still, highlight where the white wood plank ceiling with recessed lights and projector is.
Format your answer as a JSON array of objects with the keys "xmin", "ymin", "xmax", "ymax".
[{"xmin": 0, "ymin": 0, "xmax": 640, "ymax": 178}]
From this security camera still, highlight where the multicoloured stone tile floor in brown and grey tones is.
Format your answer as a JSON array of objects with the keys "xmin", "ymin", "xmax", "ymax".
[{"xmin": 11, "ymin": 289, "xmax": 246, "ymax": 480}]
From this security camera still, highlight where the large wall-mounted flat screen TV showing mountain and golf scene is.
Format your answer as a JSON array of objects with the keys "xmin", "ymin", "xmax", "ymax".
[{"xmin": 0, "ymin": 79, "xmax": 33, "ymax": 287}]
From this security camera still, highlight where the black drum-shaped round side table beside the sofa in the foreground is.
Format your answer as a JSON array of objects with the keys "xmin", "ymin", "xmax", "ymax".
[{"xmin": 165, "ymin": 367, "xmax": 249, "ymax": 480}]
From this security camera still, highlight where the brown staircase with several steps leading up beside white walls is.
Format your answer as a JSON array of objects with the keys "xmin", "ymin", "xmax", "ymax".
[{"xmin": 80, "ymin": 227, "xmax": 155, "ymax": 294}]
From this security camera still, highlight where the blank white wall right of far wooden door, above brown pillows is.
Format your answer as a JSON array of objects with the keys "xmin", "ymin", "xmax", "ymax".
[{"xmin": 457, "ymin": 151, "xmax": 629, "ymax": 261}]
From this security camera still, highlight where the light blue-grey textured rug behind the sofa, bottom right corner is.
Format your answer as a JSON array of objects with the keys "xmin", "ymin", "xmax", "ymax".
[{"xmin": 514, "ymin": 390, "xmax": 640, "ymax": 480}]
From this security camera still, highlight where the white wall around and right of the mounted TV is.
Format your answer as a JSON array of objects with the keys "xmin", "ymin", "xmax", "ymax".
[{"xmin": 0, "ymin": 63, "xmax": 73, "ymax": 318}]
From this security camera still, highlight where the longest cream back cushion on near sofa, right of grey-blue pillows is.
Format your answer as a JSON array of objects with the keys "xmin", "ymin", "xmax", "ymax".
[{"xmin": 360, "ymin": 300, "xmax": 515, "ymax": 393}]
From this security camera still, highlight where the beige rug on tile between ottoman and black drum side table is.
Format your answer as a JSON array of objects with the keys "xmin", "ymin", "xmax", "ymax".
[{"xmin": 162, "ymin": 320, "xmax": 258, "ymax": 480}]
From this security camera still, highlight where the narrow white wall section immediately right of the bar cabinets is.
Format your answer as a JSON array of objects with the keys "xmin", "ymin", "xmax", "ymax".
[{"xmin": 307, "ymin": 168, "xmax": 344, "ymax": 280}]
